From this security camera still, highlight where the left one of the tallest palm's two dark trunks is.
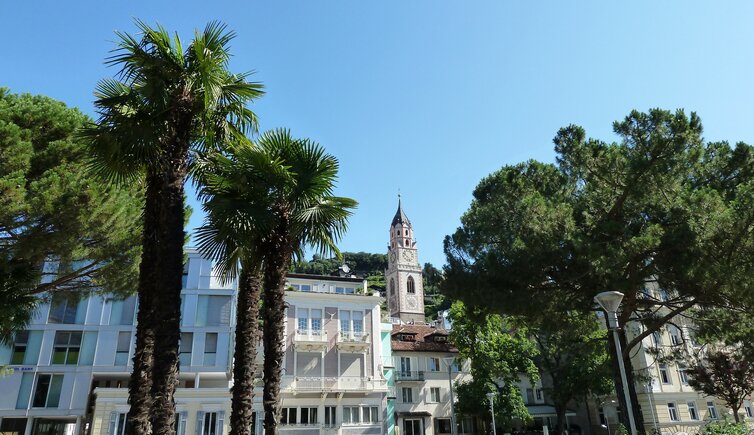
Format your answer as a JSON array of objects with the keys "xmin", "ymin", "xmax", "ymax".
[{"xmin": 128, "ymin": 174, "xmax": 160, "ymax": 435}]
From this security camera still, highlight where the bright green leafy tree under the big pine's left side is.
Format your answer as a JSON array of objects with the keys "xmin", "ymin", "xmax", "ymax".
[{"xmin": 450, "ymin": 302, "xmax": 539, "ymax": 426}]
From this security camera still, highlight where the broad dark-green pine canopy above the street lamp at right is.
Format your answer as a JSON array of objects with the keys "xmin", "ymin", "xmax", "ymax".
[{"xmin": 444, "ymin": 109, "xmax": 754, "ymax": 432}]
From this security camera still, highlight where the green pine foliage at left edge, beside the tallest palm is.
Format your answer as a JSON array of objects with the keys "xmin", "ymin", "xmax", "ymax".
[{"xmin": 0, "ymin": 89, "xmax": 142, "ymax": 340}]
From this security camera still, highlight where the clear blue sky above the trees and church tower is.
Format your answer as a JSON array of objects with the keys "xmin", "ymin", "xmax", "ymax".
[{"xmin": 0, "ymin": 0, "xmax": 754, "ymax": 265}]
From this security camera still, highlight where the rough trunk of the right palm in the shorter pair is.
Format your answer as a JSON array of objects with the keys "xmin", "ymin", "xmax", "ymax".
[{"xmin": 262, "ymin": 221, "xmax": 292, "ymax": 435}]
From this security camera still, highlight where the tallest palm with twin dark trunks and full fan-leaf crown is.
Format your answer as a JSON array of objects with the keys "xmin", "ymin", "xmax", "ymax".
[{"xmin": 82, "ymin": 21, "xmax": 263, "ymax": 435}]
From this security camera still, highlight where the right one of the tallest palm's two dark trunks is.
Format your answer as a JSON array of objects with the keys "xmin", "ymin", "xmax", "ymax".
[{"xmin": 151, "ymin": 136, "xmax": 190, "ymax": 435}]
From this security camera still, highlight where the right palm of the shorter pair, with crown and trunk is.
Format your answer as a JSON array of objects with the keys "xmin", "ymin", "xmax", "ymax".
[{"xmin": 253, "ymin": 130, "xmax": 357, "ymax": 434}]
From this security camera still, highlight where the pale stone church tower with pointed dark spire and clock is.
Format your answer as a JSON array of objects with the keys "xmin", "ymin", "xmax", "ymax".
[{"xmin": 385, "ymin": 195, "xmax": 425, "ymax": 322}]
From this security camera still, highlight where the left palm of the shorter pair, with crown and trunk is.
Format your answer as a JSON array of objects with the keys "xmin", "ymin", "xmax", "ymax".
[{"xmin": 194, "ymin": 144, "xmax": 289, "ymax": 435}]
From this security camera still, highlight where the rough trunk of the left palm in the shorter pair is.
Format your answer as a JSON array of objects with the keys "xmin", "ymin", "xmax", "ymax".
[{"xmin": 230, "ymin": 266, "xmax": 262, "ymax": 435}]
